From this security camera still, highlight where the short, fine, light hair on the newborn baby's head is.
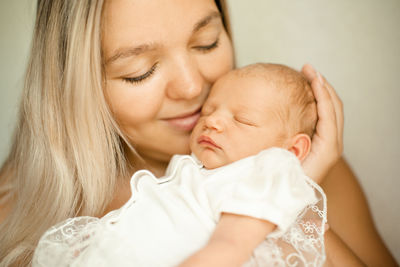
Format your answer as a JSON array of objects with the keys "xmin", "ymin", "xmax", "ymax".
[{"xmin": 233, "ymin": 63, "xmax": 317, "ymax": 139}]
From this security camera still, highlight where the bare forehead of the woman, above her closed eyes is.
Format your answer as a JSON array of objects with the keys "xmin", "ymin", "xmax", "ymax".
[{"xmin": 102, "ymin": 0, "xmax": 221, "ymax": 58}]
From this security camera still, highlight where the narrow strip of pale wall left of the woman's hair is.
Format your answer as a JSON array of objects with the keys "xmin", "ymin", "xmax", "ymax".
[{"xmin": 0, "ymin": 0, "xmax": 36, "ymax": 159}]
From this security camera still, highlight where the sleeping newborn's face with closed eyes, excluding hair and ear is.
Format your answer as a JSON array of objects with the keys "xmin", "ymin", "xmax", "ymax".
[{"xmin": 190, "ymin": 73, "xmax": 283, "ymax": 169}]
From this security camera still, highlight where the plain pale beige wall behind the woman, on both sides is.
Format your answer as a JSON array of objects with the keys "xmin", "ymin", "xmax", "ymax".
[{"xmin": 0, "ymin": 0, "xmax": 400, "ymax": 261}]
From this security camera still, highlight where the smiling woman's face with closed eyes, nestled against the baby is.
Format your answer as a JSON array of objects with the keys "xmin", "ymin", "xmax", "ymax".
[{"xmin": 102, "ymin": 0, "xmax": 233, "ymax": 168}]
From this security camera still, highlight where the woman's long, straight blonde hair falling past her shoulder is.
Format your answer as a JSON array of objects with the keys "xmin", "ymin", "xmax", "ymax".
[{"xmin": 0, "ymin": 0, "xmax": 228, "ymax": 266}]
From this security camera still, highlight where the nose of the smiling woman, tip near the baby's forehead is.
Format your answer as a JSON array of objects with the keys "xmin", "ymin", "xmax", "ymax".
[{"xmin": 167, "ymin": 56, "xmax": 204, "ymax": 99}]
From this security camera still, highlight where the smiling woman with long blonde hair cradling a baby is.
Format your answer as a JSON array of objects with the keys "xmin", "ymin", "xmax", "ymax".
[{"xmin": 0, "ymin": 0, "xmax": 395, "ymax": 266}]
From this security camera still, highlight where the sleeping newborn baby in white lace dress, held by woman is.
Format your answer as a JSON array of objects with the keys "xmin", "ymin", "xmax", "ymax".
[{"xmin": 33, "ymin": 64, "xmax": 326, "ymax": 267}]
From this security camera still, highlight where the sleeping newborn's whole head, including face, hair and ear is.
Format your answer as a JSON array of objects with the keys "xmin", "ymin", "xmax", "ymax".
[{"xmin": 190, "ymin": 63, "xmax": 317, "ymax": 169}]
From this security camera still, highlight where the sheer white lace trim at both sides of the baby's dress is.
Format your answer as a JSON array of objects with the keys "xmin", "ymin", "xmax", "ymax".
[{"xmin": 32, "ymin": 180, "xmax": 327, "ymax": 267}]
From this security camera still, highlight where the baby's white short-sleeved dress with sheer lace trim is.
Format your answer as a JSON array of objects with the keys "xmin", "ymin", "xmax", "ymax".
[{"xmin": 33, "ymin": 148, "xmax": 326, "ymax": 267}]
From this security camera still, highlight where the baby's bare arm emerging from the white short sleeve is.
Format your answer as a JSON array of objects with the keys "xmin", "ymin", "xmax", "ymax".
[{"xmin": 179, "ymin": 213, "xmax": 276, "ymax": 267}]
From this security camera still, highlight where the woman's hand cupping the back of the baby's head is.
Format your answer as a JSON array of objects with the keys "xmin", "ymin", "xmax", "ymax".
[{"xmin": 301, "ymin": 64, "xmax": 343, "ymax": 183}]
